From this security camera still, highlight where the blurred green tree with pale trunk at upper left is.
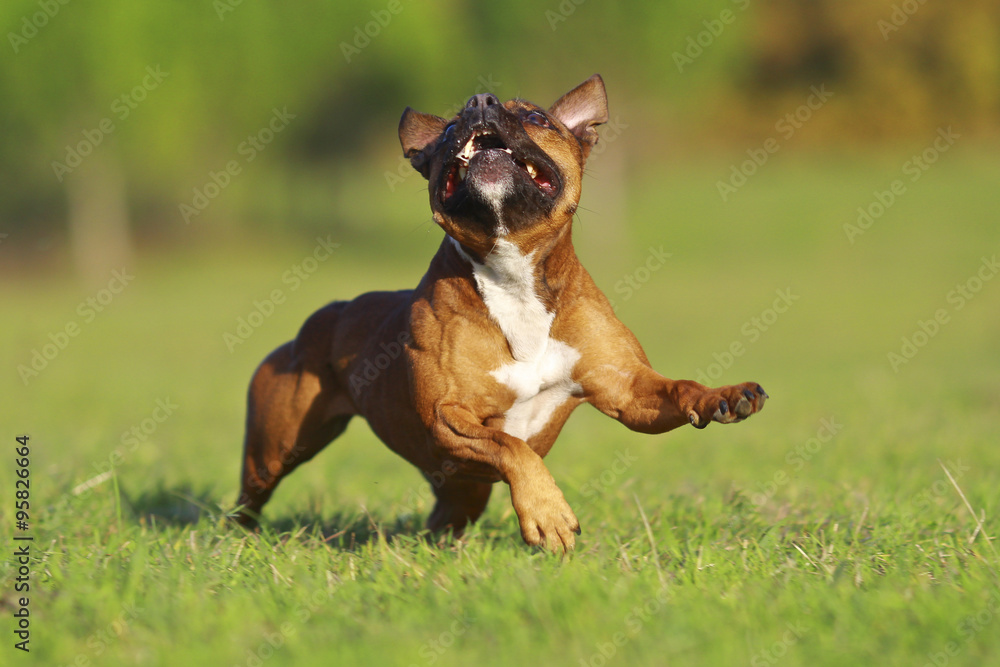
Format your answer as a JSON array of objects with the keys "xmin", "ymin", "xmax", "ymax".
[{"xmin": 0, "ymin": 0, "xmax": 342, "ymax": 278}]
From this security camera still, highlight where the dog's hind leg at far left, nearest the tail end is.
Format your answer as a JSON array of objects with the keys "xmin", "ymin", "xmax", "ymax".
[{"xmin": 237, "ymin": 335, "xmax": 354, "ymax": 527}]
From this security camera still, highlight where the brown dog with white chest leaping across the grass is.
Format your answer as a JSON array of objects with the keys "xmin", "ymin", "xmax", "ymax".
[{"xmin": 234, "ymin": 75, "xmax": 767, "ymax": 549}]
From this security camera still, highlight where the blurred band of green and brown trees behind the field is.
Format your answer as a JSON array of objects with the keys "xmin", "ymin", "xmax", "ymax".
[{"xmin": 0, "ymin": 0, "xmax": 1000, "ymax": 278}]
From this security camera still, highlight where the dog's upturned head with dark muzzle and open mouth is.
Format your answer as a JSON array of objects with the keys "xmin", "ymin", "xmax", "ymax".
[{"xmin": 399, "ymin": 74, "xmax": 608, "ymax": 253}]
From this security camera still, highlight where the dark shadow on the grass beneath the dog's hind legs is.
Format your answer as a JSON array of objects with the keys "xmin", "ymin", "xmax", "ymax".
[{"xmin": 122, "ymin": 484, "xmax": 468, "ymax": 551}]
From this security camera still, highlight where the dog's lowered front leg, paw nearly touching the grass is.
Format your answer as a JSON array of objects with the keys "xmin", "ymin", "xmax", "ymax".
[{"xmin": 434, "ymin": 405, "xmax": 580, "ymax": 551}]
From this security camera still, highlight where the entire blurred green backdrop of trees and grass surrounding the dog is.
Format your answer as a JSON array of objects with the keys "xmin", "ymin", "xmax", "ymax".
[{"xmin": 0, "ymin": 0, "xmax": 1000, "ymax": 665}]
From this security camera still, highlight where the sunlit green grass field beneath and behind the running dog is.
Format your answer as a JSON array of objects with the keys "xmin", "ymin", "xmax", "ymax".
[{"xmin": 0, "ymin": 147, "xmax": 1000, "ymax": 667}]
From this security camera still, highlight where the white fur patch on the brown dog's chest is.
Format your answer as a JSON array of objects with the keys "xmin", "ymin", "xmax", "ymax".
[{"xmin": 453, "ymin": 240, "xmax": 582, "ymax": 440}]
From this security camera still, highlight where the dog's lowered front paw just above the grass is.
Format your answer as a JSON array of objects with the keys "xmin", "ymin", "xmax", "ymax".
[{"xmin": 510, "ymin": 482, "xmax": 580, "ymax": 552}]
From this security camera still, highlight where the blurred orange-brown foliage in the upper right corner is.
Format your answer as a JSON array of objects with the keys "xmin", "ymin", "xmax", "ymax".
[{"xmin": 742, "ymin": 0, "xmax": 1000, "ymax": 142}]
